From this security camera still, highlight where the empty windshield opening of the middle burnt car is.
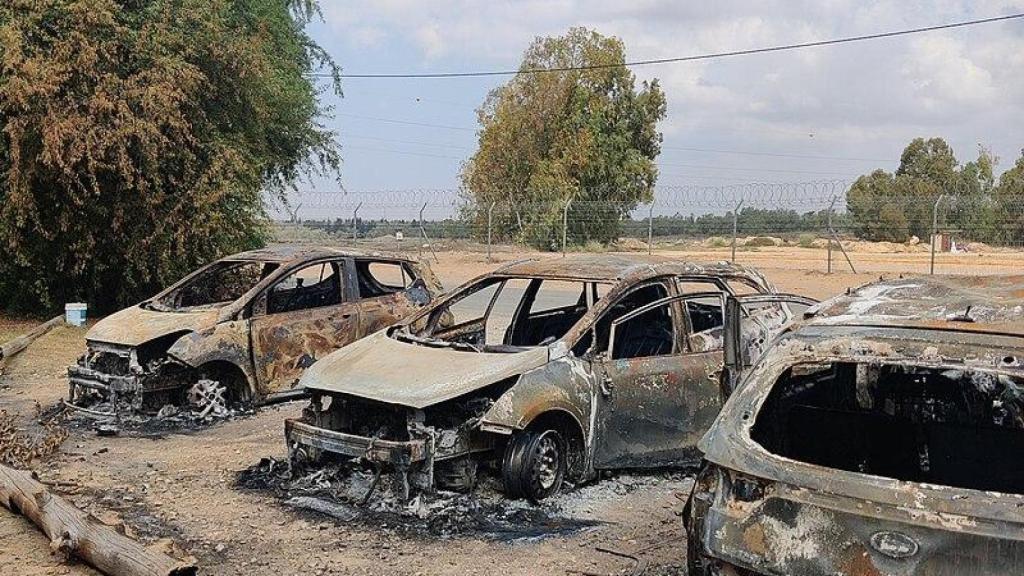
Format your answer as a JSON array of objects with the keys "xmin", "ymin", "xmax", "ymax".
[{"xmin": 398, "ymin": 278, "xmax": 607, "ymax": 352}]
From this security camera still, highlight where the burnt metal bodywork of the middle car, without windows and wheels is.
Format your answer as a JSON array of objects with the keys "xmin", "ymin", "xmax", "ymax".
[{"xmin": 286, "ymin": 256, "xmax": 788, "ymax": 496}]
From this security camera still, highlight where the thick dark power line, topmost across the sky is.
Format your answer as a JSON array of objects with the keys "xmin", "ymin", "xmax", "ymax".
[{"xmin": 309, "ymin": 12, "xmax": 1024, "ymax": 78}]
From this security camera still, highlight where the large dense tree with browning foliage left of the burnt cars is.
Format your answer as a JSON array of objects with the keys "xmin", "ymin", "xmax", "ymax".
[{"xmin": 0, "ymin": 0, "xmax": 339, "ymax": 311}]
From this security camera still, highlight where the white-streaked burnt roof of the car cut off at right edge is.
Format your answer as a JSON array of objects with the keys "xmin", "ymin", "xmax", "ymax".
[{"xmin": 804, "ymin": 275, "xmax": 1024, "ymax": 336}]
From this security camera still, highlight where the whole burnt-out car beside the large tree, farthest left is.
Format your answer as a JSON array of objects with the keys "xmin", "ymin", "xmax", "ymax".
[{"xmin": 68, "ymin": 246, "xmax": 441, "ymax": 417}]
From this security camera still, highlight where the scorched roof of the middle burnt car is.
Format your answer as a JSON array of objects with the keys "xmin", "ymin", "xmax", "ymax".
[{"xmin": 494, "ymin": 254, "xmax": 768, "ymax": 286}]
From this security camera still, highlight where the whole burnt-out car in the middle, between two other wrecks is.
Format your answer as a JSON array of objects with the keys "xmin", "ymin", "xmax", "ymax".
[{"xmin": 286, "ymin": 256, "xmax": 807, "ymax": 501}]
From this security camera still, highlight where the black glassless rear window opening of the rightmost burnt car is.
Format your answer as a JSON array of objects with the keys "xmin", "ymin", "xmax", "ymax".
[{"xmin": 752, "ymin": 363, "xmax": 1024, "ymax": 494}]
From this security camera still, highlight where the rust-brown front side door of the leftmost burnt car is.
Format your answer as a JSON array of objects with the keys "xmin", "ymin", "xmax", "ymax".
[{"xmin": 249, "ymin": 256, "xmax": 361, "ymax": 399}]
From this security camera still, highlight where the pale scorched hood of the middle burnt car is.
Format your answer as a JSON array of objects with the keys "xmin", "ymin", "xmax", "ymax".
[{"xmin": 299, "ymin": 331, "xmax": 548, "ymax": 409}]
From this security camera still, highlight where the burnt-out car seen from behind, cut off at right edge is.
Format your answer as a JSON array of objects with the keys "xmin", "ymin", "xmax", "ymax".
[{"xmin": 683, "ymin": 276, "xmax": 1024, "ymax": 576}]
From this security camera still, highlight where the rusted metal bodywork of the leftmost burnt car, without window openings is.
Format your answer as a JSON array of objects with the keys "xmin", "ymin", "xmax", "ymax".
[{"xmin": 69, "ymin": 246, "xmax": 440, "ymax": 409}]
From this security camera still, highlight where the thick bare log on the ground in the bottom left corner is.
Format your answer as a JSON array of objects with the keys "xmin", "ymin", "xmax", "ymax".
[{"xmin": 0, "ymin": 464, "xmax": 197, "ymax": 576}]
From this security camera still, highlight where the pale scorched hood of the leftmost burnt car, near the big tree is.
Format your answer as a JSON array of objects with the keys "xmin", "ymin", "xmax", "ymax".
[{"xmin": 85, "ymin": 305, "xmax": 220, "ymax": 346}]
